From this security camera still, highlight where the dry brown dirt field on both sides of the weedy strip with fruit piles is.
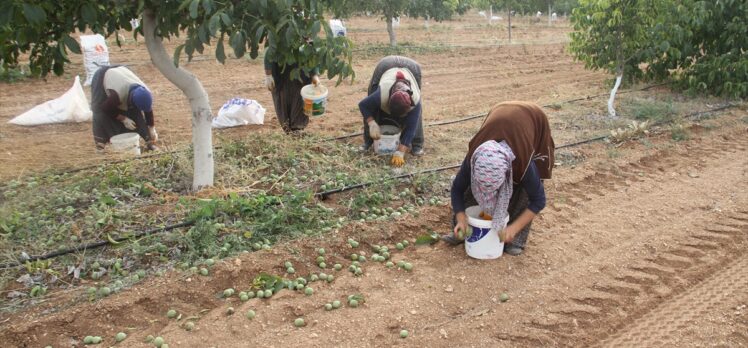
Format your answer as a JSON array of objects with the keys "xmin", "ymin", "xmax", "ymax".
[{"xmin": 0, "ymin": 14, "xmax": 748, "ymax": 347}]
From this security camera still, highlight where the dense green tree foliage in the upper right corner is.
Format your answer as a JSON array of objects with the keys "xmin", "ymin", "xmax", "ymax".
[{"xmin": 570, "ymin": 0, "xmax": 748, "ymax": 98}]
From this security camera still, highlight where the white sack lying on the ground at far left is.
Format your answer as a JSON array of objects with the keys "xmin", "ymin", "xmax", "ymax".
[{"xmin": 8, "ymin": 76, "xmax": 93, "ymax": 126}]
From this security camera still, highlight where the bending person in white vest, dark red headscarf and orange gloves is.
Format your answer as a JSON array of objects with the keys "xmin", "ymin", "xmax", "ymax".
[{"xmin": 358, "ymin": 56, "xmax": 423, "ymax": 167}]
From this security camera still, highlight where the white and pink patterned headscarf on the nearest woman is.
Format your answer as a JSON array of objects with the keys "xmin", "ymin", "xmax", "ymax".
[{"xmin": 470, "ymin": 140, "xmax": 515, "ymax": 229}]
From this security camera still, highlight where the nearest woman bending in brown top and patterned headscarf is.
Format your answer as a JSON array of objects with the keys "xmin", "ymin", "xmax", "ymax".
[{"xmin": 443, "ymin": 102, "xmax": 554, "ymax": 255}]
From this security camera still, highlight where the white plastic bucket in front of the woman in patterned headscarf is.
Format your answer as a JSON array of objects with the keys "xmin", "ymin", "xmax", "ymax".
[{"xmin": 465, "ymin": 205, "xmax": 509, "ymax": 260}]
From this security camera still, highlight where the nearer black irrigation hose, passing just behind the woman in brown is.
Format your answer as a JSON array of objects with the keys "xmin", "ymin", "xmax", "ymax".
[{"xmin": 0, "ymin": 98, "xmax": 737, "ymax": 269}]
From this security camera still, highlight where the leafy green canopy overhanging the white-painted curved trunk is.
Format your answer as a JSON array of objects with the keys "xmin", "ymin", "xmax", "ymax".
[{"xmin": 0, "ymin": 0, "xmax": 354, "ymax": 83}]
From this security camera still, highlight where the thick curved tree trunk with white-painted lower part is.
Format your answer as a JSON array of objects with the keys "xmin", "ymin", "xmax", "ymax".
[{"xmin": 142, "ymin": 9, "xmax": 213, "ymax": 191}]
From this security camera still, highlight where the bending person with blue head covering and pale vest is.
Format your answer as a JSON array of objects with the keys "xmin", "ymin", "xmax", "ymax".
[{"xmin": 91, "ymin": 66, "xmax": 158, "ymax": 150}]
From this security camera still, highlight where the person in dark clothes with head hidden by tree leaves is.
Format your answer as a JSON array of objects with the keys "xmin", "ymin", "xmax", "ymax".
[{"xmin": 265, "ymin": 51, "xmax": 319, "ymax": 134}]
